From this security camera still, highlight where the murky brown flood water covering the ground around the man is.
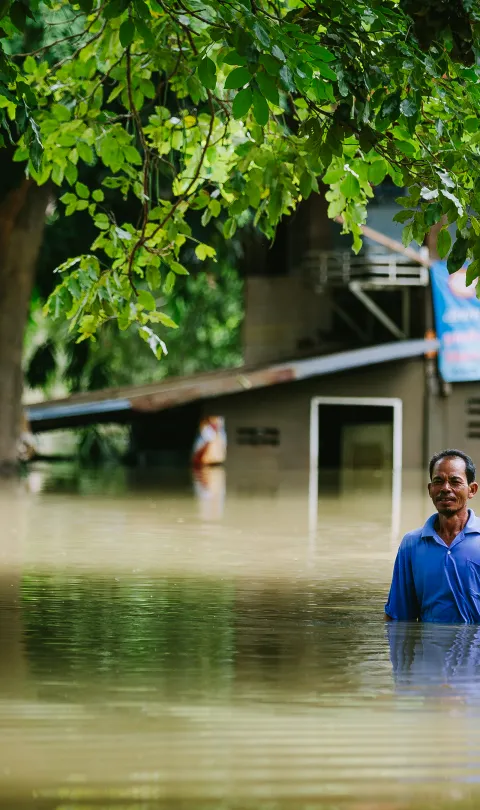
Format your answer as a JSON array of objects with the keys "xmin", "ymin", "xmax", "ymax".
[{"xmin": 0, "ymin": 466, "xmax": 480, "ymax": 810}]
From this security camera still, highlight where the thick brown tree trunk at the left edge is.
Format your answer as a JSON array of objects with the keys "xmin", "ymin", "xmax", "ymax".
[{"xmin": 0, "ymin": 166, "xmax": 49, "ymax": 474}]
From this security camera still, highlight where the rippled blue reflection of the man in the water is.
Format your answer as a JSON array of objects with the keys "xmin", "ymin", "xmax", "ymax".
[{"xmin": 386, "ymin": 622, "xmax": 480, "ymax": 702}]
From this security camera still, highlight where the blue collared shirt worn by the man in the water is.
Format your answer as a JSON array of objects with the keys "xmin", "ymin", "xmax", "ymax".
[{"xmin": 385, "ymin": 509, "xmax": 480, "ymax": 624}]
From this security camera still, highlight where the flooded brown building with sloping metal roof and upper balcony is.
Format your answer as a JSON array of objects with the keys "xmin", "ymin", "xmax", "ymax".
[{"xmin": 29, "ymin": 188, "xmax": 480, "ymax": 471}]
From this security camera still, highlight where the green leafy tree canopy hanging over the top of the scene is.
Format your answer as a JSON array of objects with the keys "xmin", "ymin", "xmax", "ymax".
[{"xmin": 0, "ymin": 0, "xmax": 480, "ymax": 356}]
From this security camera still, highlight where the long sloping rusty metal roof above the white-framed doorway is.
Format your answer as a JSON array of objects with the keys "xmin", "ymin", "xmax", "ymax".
[{"xmin": 26, "ymin": 340, "xmax": 438, "ymax": 431}]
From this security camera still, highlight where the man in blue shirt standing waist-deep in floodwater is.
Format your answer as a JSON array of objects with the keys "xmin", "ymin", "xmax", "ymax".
[{"xmin": 385, "ymin": 450, "xmax": 480, "ymax": 624}]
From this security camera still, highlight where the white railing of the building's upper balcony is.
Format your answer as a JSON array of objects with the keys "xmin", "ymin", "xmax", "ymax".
[{"xmin": 301, "ymin": 250, "xmax": 429, "ymax": 289}]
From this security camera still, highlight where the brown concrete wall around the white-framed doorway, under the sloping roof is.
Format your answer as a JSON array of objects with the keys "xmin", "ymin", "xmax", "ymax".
[{"xmin": 204, "ymin": 359, "xmax": 425, "ymax": 473}]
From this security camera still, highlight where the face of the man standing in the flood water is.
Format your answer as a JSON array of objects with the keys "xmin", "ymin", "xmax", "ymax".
[{"xmin": 428, "ymin": 456, "xmax": 478, "ymax": 517}]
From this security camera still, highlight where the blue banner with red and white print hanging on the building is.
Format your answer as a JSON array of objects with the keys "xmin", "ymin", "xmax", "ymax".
[{"xmin": 430, "ymin": 262, "xmax": 480, "ymax": 382}]
